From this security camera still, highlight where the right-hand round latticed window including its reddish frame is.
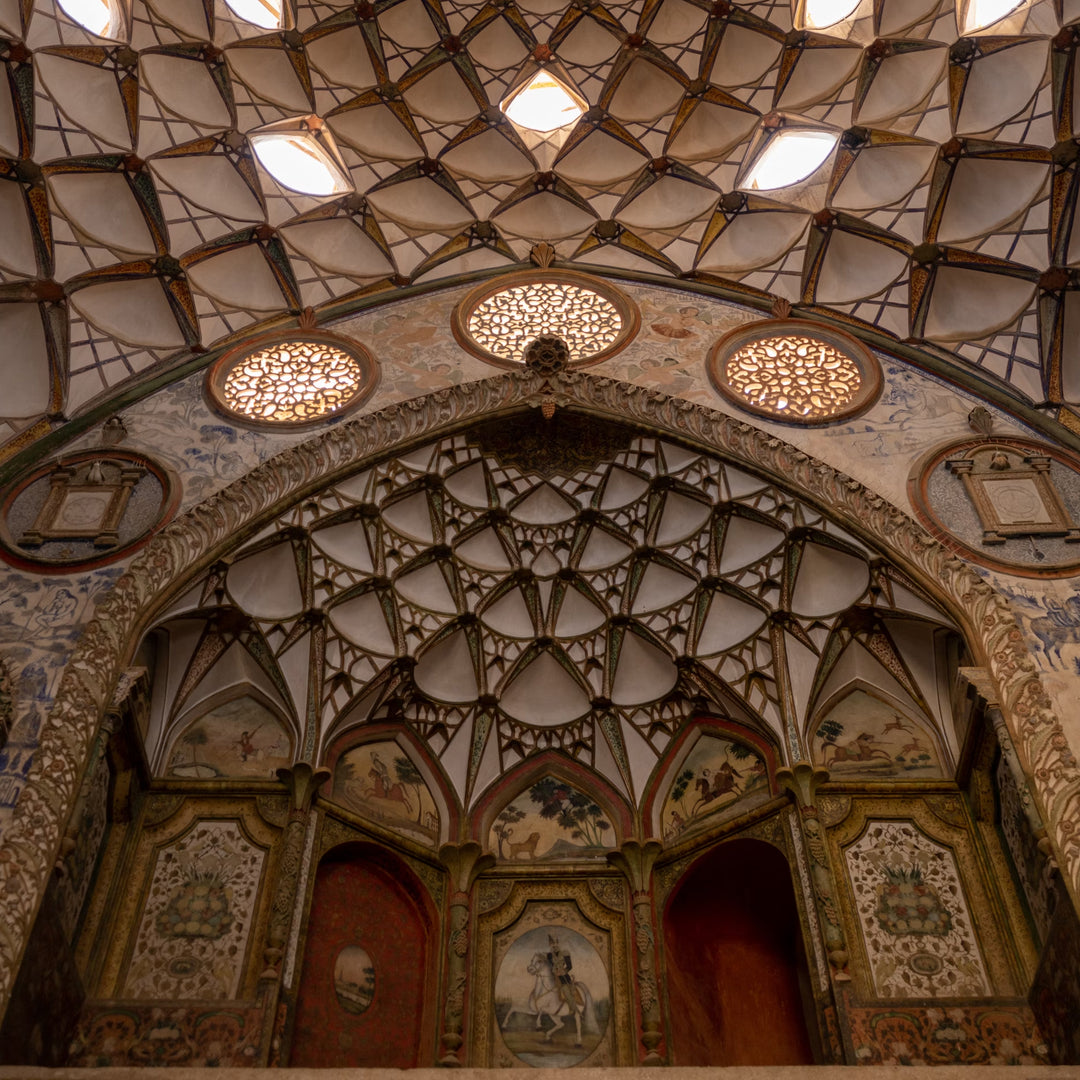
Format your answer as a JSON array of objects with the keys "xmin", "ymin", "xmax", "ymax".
[{"xmin": 708, "ymin": 320, "xmax": 881, "ymax": 424}]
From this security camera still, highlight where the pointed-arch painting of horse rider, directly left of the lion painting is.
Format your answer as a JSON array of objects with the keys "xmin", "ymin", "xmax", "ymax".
[{"xmin": 332, "ymin": 740, "xmax": 438, "ymax": 845}]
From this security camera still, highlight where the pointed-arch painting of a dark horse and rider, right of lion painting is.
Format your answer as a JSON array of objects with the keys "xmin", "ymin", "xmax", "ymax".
[{"xmin": 662, "ymin": 735, "xmax": 769, "ymax": 840}]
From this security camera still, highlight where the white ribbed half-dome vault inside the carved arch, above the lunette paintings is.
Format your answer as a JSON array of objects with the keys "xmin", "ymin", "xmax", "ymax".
[{"xmin": 148, "ymin": 410, "xmax": 958, "ymax": 806}]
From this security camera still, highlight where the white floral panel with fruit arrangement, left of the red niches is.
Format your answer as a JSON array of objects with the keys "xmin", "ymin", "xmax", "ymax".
[{"xmin": 123, "ymin": 821, "xmax": 266, "ymax": 1000}]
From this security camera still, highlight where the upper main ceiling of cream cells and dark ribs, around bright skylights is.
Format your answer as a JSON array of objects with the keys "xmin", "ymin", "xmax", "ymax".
[{"xmin": 0, "ymin": 0, "xmax": 1080, "ymax": 449}]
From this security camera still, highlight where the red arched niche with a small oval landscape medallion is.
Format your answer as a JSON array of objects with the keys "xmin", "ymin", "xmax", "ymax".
[{"xmin": 291, "ymin": 845, "xmax": 436, "ymax": 1068}]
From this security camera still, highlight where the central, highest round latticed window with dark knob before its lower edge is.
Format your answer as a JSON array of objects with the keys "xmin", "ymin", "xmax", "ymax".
[{"xmin": 453, "ymin": 270, "xmax": 640, "ymax": 367}]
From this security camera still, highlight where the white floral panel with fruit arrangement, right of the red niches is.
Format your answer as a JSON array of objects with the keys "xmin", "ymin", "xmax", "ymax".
[{"xmin": 845, "ymin": 821, "xmax": 991, "ymax": 998}]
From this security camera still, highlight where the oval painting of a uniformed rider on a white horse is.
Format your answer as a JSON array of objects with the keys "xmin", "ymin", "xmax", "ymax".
[{"xmin": 495, "ymin": 924, "xmax": 611, "ymax": 1068}]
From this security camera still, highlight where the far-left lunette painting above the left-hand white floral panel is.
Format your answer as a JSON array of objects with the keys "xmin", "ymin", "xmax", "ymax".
[{"xmin": 165, "ymin": 696, "xmax": 292, "ymax": 780}]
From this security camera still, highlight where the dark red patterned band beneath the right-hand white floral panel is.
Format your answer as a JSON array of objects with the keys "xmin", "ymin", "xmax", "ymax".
[{"xmin": 845, "ymin": 1004, "xmax": 1049, "ymax": 1065}]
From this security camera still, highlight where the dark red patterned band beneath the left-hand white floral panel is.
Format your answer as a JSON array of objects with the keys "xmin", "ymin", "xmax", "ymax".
[{"xmin": 67, "ymin": 1002, "xmax": 262, "ymax": 1068}]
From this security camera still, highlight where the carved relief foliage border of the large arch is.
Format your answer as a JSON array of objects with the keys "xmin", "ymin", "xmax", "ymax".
[{"xmin": 0, "ymin": 370, "xmax": 1080, "ymax": 1008}]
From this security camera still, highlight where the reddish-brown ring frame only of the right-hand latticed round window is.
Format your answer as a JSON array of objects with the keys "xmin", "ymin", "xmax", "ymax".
[{"xmin": 705, "ymin": 319, "xmax": 882, "ymax": 428}]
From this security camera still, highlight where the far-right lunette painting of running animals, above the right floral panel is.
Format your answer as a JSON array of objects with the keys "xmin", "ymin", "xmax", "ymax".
[{"xmin": 812, "ymin": 690, "xmax": 944, "ymax": 779}]
